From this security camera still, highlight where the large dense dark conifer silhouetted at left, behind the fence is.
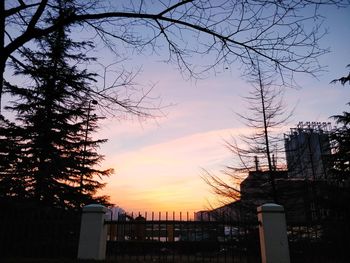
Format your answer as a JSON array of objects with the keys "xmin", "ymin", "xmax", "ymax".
[{"xmin": 0, "ymin": 18, "xmax": 111, "ymax": 208}]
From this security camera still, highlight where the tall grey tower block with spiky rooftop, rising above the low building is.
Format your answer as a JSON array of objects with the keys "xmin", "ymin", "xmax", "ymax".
[{"xmin": 285, "ymin": 122, "xmax": 332, "ymax": 180}]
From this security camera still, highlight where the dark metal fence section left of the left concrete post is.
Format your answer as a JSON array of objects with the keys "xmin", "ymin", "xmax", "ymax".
[{"xmin": 0, "ymin": 204, "xmax": 81, "ymax": 261}]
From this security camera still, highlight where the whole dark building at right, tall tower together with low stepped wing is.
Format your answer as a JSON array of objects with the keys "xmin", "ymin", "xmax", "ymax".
[{"xmin": 196, "ymin": 122, "xmax": 332, "ymax": 221}]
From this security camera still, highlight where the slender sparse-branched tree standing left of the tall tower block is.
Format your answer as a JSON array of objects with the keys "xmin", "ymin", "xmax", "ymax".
[{"xmin": 203, "ymin": 61, "xmax": 292, "ymax": 206}]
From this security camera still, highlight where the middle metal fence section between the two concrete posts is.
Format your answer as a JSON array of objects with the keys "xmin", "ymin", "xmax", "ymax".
[{"xmin": 106, "ymin": 213, "xmax": 260, "ymax": 263}]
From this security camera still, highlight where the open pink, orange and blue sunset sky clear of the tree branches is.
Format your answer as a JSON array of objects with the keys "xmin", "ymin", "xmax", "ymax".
[{"xmin": 98, "ymin": 6, "xmax": 350, "ymax": 212}]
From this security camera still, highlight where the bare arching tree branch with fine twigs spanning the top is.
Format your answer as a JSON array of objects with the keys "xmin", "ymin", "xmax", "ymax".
[{"xmin": 0, "ymin": 0, "xmax": 349, "ymax": 112}]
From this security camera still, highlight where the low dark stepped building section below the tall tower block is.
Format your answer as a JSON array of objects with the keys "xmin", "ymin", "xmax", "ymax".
[{"xmin": 195, "ymin": 171, "xmax": 327, "ymax": 225}]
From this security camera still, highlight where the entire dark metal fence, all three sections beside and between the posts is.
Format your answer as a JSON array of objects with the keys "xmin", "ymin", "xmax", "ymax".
[{"xmin": 0, "ymin": 203, "xmax": 350, "ymax": 263}]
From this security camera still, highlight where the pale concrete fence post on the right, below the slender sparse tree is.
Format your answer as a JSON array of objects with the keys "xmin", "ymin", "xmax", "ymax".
[{"xmin": 257, "ymin": 204, "xmax": 290, "ymax": 263}]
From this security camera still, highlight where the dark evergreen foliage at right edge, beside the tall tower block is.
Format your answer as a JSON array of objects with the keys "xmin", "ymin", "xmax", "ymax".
[{"xmin": 317, "ymin": 106, "xmax": 350, "ymax": 251}]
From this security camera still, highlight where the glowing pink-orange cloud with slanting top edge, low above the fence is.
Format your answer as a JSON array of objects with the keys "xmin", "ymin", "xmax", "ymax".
[{"xmin": 100, "ymin": 129, "xmax": 249, "ymax": 214}]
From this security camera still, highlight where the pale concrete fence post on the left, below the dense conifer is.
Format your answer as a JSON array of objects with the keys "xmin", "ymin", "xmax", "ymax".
[{"xmin": 78, "ymin": 204, "xmax": 107, "ymax": 260}]
